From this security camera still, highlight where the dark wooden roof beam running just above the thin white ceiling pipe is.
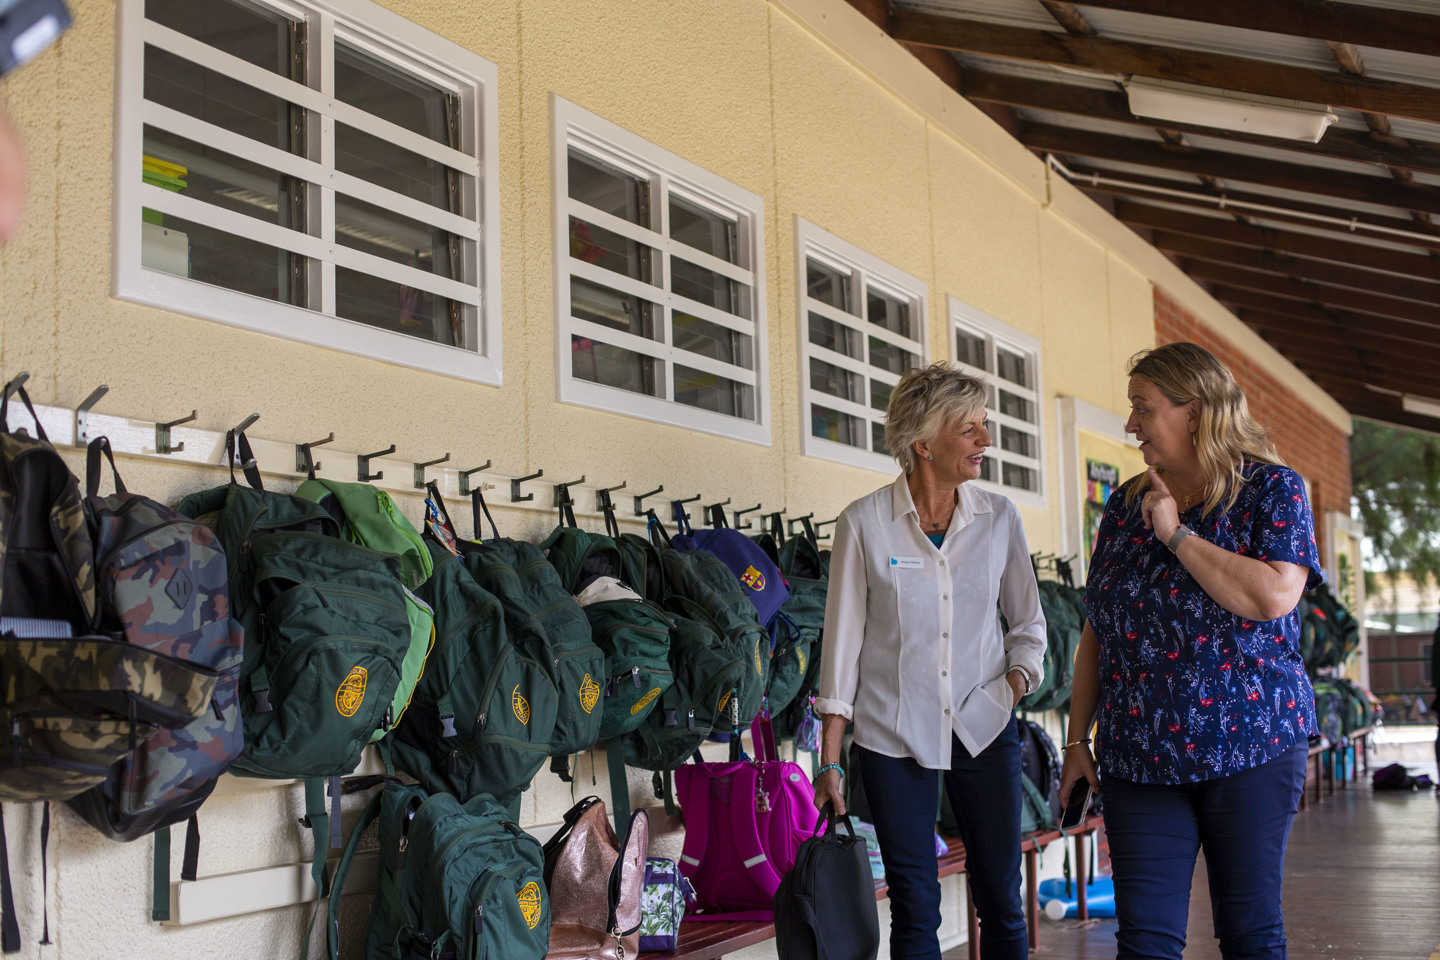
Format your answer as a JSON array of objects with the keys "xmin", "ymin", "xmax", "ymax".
[{"xmin": 1020, "ymin": 123, "xmax": 1440, "ymax": 213}]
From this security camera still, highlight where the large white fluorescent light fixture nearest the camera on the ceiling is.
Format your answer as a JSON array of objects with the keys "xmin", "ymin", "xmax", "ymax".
[{"xmin": 1125, "ymin": 76, "xmax": 1338, "ymax": 144}]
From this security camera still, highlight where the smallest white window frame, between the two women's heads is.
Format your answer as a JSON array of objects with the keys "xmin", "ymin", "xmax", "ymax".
[{"xmin": 946, "ymin": 295, "xmax": 1048, "ymax": 510}]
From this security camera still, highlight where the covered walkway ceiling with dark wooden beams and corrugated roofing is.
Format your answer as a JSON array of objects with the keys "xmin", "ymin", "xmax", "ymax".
[{"xmin": 851, "ymin": 0, "xmax": 1440, "ymax": 432}]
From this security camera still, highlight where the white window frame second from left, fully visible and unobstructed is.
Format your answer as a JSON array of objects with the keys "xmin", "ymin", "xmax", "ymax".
[{"xmin": 550, "ymin": 94, "xmax": 770, "ymax": 446}]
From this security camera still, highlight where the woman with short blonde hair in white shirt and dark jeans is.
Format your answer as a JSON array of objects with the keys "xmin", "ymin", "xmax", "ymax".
[{"xmin": 815, "ymin": 363, "xmax": 1045, "ymax": 960}]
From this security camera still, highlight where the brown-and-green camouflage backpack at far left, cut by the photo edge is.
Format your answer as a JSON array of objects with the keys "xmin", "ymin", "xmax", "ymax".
[{"xmin": 0, "ymin": 389, "xmax": 216, "ymax": 800}]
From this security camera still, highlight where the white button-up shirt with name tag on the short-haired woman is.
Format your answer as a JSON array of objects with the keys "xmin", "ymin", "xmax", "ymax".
[{"xmin": 815, "ymin": 475, "xmax": 1045, "ymax": 770}]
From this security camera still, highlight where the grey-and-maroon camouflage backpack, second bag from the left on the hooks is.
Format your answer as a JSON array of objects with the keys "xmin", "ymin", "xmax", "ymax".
[{"xmin": 69, "ymin": 436, "xmax": 245, "ymax": 841}]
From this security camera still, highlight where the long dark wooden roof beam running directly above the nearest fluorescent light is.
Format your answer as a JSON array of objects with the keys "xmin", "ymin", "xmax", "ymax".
[{"xmin": 890, "ymin": 4, "xmax": 1440, "ymax": 122}]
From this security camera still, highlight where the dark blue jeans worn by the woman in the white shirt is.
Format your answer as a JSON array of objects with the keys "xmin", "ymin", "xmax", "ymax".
[{"xmin": 860, "ymin": 717, "xmax": 1028, "ymax": 960}]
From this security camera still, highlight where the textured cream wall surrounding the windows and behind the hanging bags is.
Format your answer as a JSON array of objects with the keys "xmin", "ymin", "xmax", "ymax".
[{"xmin": 0, "ymin": 0, "xmax": 1324, "ymax": 960}]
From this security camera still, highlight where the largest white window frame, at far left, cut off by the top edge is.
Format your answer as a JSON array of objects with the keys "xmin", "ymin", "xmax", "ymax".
[{"xmin": 111, "ymin": 0, "xmax": 501, "ymax": 386}]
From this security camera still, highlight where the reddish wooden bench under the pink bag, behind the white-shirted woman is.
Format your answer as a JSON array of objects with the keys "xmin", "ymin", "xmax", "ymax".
[{"xmin": 641, "ymin": 816, "xmax": 1102, "ymax": 960}]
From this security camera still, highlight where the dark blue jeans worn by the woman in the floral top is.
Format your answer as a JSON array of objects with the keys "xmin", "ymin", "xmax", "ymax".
[{"xmin": 1102, "ymin": 743, "xmax": 1306, "ymax": 960}]
